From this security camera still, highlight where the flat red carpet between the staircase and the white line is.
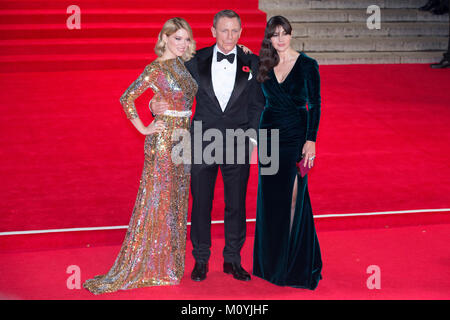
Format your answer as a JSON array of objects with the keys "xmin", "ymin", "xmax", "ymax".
[{"xmin": 0, "ymin": 65, "xmax": 450, "ymax": 240}]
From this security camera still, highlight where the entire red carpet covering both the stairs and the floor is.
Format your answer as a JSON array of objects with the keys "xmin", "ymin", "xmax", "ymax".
[{"xmin": 0, "ymin": 0, "xmax": 450, "ymax": 299}]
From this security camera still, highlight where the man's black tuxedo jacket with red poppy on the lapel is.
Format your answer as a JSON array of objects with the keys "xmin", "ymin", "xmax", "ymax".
[{"xmin": 186, "ymin": 46, "xmax": 265, "ymax": 133}]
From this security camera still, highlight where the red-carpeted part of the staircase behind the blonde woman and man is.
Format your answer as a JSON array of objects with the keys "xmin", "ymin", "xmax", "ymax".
[{"xmin": 0, "ymin": 0, "xmax": 266, "ymax": 72}]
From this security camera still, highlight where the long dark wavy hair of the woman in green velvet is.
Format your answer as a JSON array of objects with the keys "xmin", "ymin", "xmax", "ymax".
[{"xmin": 256, "ymin": 16, "xmax": 292, "ymax": 82}]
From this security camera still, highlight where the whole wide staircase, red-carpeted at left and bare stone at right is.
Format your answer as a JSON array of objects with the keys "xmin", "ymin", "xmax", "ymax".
[{"xmin": 0, "ymin": 0, "xmax": 448, "ymax": 72}]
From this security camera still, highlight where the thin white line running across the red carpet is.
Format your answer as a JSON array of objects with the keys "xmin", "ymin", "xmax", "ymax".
[{"xmin": 0, "ymin": 208, "xmax": 450, "ymax": 236}]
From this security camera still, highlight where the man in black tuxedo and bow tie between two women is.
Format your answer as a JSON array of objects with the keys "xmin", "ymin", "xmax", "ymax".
[{"xmin": 186, "ymin": 10, "xmax": 265, "ymax": 281}]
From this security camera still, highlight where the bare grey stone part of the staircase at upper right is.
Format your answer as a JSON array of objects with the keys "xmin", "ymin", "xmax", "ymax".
[{"xmin": 259, "ymin": 0, "xmax": 449, "ymax": 64}]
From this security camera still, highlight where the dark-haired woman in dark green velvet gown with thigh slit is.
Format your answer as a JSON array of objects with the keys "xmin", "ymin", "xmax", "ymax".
[{"xmin": 253, "ymin": 16, "xmax": 322, "ymax": 290}]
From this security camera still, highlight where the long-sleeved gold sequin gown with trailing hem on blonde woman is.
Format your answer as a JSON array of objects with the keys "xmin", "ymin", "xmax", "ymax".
[{"xmin": 83, "ymin": 58, "xmax": 198, "ymax": 294}]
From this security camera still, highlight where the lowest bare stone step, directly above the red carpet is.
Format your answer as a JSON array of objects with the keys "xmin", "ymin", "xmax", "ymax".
[{"xmin": 305, "ymin": 51, "xmax": 443, "ymax": 65}]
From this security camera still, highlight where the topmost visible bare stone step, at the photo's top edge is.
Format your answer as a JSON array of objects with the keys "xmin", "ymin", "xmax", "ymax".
[{"xmin": 259, "ymin": 0, "xmax": 427, "ymax": 11}]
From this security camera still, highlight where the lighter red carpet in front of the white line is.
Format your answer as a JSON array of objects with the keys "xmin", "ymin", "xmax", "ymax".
[{"xmin": 0, "ymin": 225, "xmax": 450, "ymax": 300}]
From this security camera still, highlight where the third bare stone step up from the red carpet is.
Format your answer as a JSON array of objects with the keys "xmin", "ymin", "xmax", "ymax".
[{"xmin": 292, "ymin": 22, "xmax": 448, "ymax": 38}]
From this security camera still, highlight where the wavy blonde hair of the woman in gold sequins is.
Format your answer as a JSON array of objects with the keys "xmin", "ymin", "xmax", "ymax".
[{"xmin": 155, "ymin": 18, "xmax": 195, "ymax": 61}]
